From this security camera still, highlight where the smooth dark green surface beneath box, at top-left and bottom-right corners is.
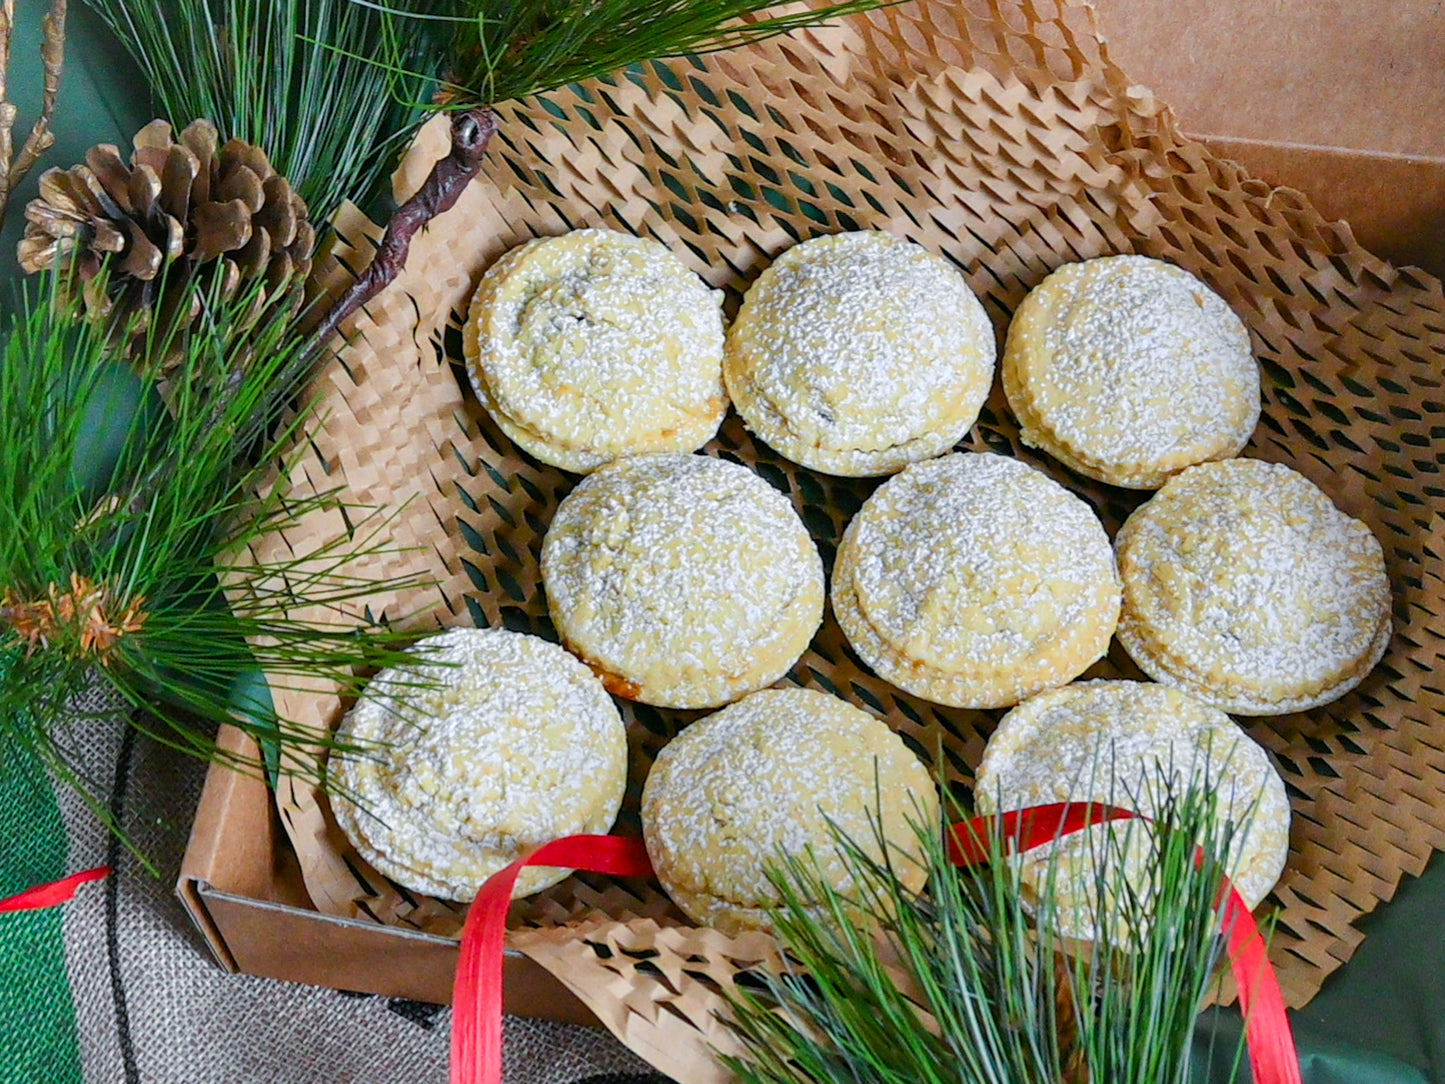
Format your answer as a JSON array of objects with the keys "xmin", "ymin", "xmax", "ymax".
[{"xmin": 0, "ymin": 0, "xmax": 1445, "ymax": 1084}]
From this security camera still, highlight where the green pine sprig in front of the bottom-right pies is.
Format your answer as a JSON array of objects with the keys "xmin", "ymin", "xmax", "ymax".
[{"xmin": 728, "ymin": 788, "xmax": 1260, "ymax": 1084}]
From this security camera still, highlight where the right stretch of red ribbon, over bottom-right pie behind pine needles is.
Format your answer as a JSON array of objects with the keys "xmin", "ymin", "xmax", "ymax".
[{"xmin": 948, "ymin": 802, "xmax": 1302, "ymax": 1084}]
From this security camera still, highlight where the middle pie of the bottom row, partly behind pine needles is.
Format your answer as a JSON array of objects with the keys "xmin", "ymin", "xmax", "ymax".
[{"xmin": 642, "ymin": 688, "xmax": 938, "ymax": 934}]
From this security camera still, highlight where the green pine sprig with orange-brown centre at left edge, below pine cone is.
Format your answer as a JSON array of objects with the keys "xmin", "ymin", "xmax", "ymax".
[{"xmin": 0, "ymin": 279, "xmax": 424, "ymax": 849}]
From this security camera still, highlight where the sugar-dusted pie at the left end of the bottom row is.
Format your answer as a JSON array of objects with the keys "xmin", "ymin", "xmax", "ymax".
[{"xmin": 329, "ymin": 629, "xmax": 627, "ymax": 900}]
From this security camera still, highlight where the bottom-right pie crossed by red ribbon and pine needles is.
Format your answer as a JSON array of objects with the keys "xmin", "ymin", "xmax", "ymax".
[{"xmin": 974, "ymin": 681, "xmax": 1289, "ymax": 939}]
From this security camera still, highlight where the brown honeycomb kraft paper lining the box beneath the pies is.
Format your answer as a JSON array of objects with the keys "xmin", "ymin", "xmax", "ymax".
[{"xmin": 245, "ymin": 0, "xmax": 1445, "ymax": 1081}]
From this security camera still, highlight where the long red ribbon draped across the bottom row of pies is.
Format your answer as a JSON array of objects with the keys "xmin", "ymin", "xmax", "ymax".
[{"xmin": 451, "ymin": 802, "xmax": 1302, "ymax": 1084}]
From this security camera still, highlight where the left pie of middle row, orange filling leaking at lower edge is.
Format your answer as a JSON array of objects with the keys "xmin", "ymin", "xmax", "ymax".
[{"xmin": 542, "ymin": 455, "xmax": 824, "ymax": 708}]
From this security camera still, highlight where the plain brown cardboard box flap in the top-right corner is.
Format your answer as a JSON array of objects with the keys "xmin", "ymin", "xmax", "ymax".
[{"xmin": 1095, "ymin": 0, "xmax": 1445, "ymax": 276}]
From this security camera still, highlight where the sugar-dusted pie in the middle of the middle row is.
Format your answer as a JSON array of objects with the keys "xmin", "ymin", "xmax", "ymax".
[{"xmin": 832, "ymin": 452, "xmax": 1118, "ymax": 708}]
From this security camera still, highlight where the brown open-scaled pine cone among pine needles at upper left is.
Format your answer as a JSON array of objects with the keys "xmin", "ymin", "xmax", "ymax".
[{"xmin": 19, "ymin": 120, "xmax": 316, "ymax": 367}]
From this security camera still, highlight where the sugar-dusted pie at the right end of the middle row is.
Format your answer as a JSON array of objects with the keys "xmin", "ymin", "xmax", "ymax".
[{"xmin": 1116, "ymin": 460, "xmax": 1390, "ymax": 715}]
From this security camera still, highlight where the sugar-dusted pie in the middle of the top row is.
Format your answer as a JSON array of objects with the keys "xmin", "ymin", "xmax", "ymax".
[{"xmin": 723, "ymin": 231, "xmax": 996, "ymax": 476}]
